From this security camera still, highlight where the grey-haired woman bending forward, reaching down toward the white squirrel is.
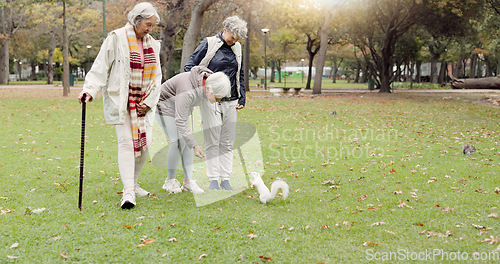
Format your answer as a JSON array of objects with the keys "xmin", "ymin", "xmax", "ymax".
[{"xmin": 156, "ymin": 66, "xmax": 231, "ymax": 194}]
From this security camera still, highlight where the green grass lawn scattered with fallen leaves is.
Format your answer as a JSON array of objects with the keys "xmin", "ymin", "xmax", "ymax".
[{"xmin": 0, "ymin": 91, "xmax": 500, "ymax": 263}]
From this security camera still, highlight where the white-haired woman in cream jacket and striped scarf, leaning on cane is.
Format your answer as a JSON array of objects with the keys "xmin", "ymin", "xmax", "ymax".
[{"xmin": 78, "ymin": 2, "xmax": 161, "ymax": 209}]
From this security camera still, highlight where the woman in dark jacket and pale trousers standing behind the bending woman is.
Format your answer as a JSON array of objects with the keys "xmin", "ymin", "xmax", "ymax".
[{"xmin": 184, "ymin": 16, "xmax": 247, "ymax": 190}]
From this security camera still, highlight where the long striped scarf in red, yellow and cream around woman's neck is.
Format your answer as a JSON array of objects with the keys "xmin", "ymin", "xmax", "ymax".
[{"xmin": 125, "ymin": 23, "xmax": 157, "ymax": 157}]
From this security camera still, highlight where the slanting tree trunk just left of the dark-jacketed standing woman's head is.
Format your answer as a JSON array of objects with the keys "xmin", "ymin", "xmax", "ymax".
[{"xmin": 180, "ymin": 0, "xmax": 217, "ymax": 72}]
